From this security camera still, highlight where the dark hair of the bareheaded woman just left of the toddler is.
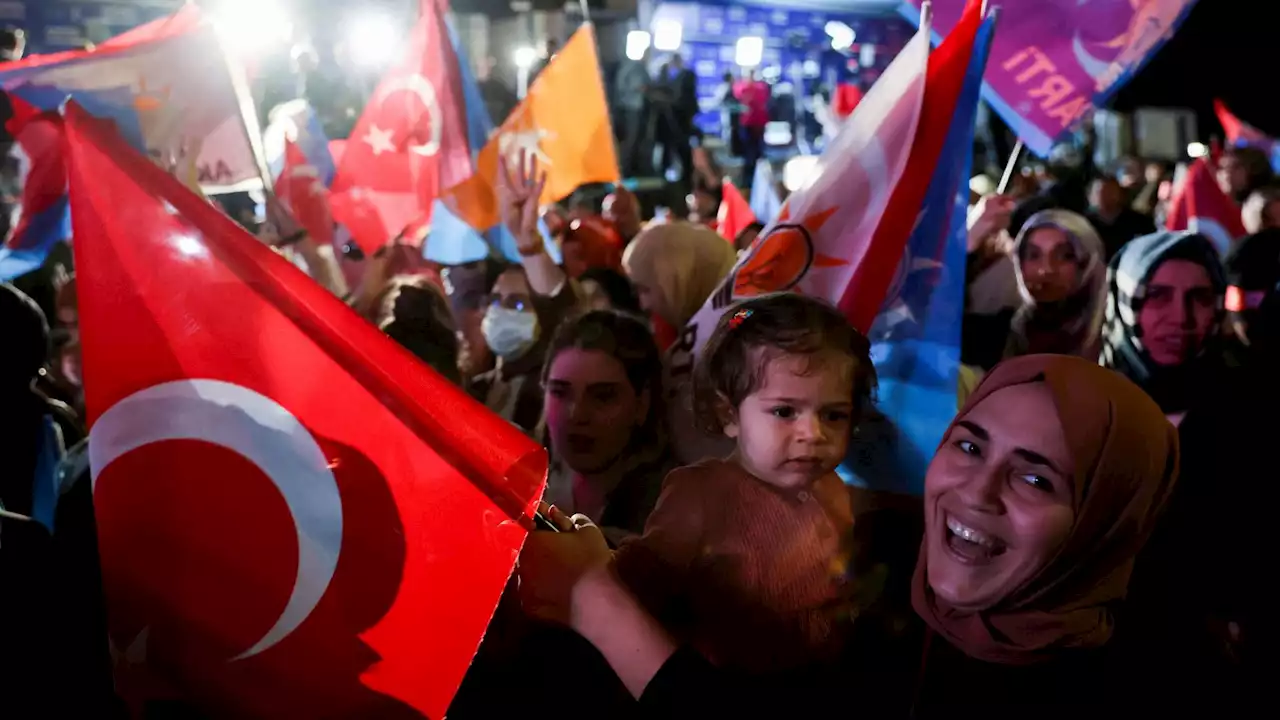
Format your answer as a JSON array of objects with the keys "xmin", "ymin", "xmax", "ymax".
[{"xmin": 543, "ymin": 310, "xmax": 667, "ymax": 441}]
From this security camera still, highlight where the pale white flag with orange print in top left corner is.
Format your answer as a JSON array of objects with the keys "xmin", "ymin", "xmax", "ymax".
[{"xmin": 0, "ymin": 5, "xmax": 259, "ymax": 190}]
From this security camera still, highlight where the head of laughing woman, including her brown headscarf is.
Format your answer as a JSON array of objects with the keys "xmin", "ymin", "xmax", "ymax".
[{"xmin": 913, "ymin": 355, "xmax": 1178, "ymax": 665}]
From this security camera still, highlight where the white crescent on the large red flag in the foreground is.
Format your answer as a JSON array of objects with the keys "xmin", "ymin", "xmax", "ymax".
[{"xmin": 88, "ymin": 379, "xmax": 343, "ymax": 660}]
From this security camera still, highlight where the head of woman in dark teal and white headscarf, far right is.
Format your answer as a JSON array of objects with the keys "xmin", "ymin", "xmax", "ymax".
[{"xmin": 1102, "ymin": 232, "xmax": 1226, "ymax": 424}]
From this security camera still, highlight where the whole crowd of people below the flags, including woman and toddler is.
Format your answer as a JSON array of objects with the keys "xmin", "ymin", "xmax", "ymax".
[{"xmin": 0, "ymin": 14, "xmax": 1280, "ymax": 717}]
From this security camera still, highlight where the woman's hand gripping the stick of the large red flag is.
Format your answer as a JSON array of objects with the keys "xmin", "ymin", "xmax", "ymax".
[{"xmin": 517, "ymin": 502, "xmax": 613, "ymax": 625}]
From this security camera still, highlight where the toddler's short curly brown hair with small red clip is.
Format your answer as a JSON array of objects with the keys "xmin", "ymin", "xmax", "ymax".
[{"xmin": 694, "ymin": 292, "xmax": 876, "ymax": 434}]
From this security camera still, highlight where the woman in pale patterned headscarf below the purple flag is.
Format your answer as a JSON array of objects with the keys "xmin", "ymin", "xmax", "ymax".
[{"xmin": 1005, "ymin": 210, "xmax": 1106, "ymax": 360}]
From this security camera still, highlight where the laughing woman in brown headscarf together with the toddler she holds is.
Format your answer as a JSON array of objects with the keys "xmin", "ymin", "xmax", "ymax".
[{"xmin": 520, "ymin": 289, "xmax": 1185, "ymax": 717}]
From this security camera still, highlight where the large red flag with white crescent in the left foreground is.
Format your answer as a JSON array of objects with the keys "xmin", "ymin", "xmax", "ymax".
[{"xmin": 65, "ymin": 105, "xmax": 545, "ymax": 717}]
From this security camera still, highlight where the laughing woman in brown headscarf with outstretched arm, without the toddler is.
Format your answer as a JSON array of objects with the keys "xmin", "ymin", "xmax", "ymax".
[{"xmin": 520, "ymin": 355, "xmax": 1198, "ymax": 717}]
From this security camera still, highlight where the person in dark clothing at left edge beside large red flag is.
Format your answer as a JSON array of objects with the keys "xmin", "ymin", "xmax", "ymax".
[{"xmin": 0, "ymin": 283, "xmax": 114, "ymax": 717}]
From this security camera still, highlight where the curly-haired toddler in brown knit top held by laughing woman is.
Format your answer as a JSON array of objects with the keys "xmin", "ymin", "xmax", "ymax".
[{"xmin": 614, "ymin": 293, "xmax": 876, "ymax": 673}]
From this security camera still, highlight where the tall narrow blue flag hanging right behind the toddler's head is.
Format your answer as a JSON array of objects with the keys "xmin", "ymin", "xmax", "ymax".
[{"xmin": 840, "ymin": 12, "xmax": 995, "ymax": 495}]
